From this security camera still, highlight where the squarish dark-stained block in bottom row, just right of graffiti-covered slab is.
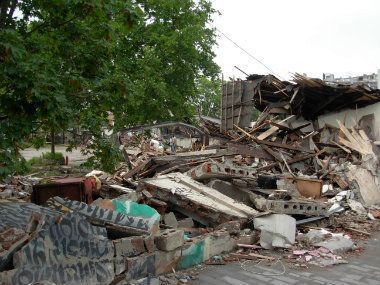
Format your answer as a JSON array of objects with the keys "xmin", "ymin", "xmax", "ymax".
[{"xmin": 126, "ymin": 253, "xmax": 156, "ymax": 280}]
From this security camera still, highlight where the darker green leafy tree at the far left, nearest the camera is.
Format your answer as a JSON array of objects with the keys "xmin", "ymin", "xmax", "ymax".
[{"xmin": 0, "ymin": 0, "xmax": 139, "ymax": 174}]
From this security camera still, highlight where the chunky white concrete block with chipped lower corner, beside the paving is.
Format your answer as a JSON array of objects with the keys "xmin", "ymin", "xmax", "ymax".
[{"xmin": 253, "ymin": 214, "xmax": 296, "ymax": 249}]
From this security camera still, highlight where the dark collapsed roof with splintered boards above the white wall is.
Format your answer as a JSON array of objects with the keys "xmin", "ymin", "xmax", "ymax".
[{"xmin": 247, "ymin": 74, "xmax": 380, "ymax": 120}]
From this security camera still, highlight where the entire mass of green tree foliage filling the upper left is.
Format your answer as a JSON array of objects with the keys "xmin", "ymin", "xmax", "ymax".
[{"xmin": 0, "ymin": 0, "xmax": 218, "ymax": 172}]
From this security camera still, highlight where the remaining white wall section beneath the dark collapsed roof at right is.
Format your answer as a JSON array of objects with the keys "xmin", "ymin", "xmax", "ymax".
[{"xmin": 318, "ymin": 102, "xmax": 380, "ymax": 140}]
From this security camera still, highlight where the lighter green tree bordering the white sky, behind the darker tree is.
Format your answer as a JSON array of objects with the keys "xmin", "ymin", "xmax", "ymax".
[{"xmin": 116, "ymin": 0, "xmax": 219, "ymax": 124}]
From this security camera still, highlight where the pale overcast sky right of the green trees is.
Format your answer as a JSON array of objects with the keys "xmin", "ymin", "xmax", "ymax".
[{"xmin": 212, "ymin": 0, "xmax": 380, "ymax": 79}]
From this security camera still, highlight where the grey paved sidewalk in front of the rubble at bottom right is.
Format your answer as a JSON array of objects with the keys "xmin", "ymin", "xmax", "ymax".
[{"xmin": 191, "ymin": 234, "xmax": 380, "ymax": 285}]
